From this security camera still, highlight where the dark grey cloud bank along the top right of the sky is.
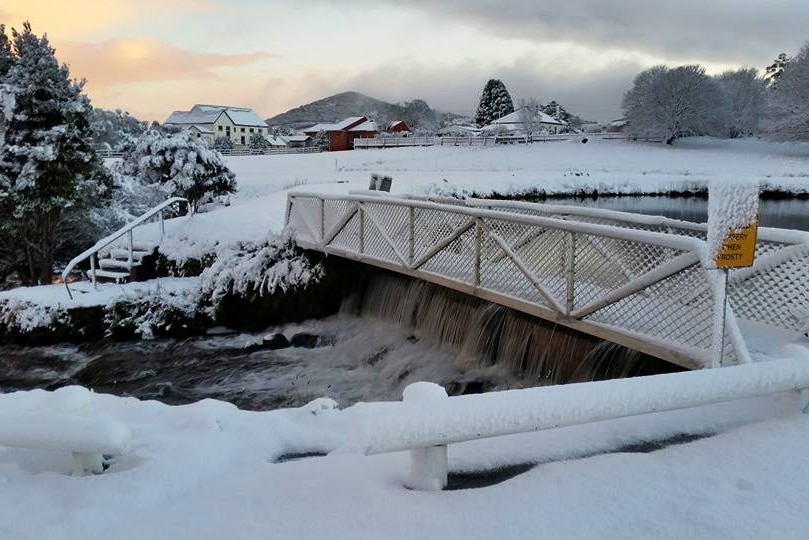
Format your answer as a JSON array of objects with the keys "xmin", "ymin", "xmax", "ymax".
[{"xmin": 364, "ymin": 0, "xmax": 809, "ymax": 65}]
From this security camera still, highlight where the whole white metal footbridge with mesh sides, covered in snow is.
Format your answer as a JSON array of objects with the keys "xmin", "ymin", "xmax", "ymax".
[{"xmin": 286, "ymin": 193, "xmax": 809, "ymax": 368}]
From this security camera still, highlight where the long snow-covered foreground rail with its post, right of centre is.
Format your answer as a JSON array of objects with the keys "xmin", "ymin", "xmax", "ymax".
[{"xmin": 349, "ymin": 356, "xmax": 809, "ymax": 490}]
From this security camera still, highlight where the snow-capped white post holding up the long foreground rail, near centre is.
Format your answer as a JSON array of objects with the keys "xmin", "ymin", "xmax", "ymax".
[{"xmin": 402, "ymin": 382, "xmax": 449, "ymax": 491}]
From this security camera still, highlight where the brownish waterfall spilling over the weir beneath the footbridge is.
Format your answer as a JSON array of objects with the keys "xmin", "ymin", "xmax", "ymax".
[{"xmin": 342, "ymin": 271, "xmax": 680, "ymax": 385}]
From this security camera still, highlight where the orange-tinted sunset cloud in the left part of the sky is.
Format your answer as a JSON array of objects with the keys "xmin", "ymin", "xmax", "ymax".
[{"xmin": 57, "ymin": 39, "xmax": 272, "ymax": 87}]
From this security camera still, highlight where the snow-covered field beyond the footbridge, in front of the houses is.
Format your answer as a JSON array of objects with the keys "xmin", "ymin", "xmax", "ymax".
[{"xmin": 133, "ymin": 138, "xmax": 809, "ymax": 260}]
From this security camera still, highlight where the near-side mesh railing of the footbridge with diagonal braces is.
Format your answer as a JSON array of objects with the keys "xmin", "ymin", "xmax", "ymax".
[{"xmin": 287, "ymin": 193, "xmax": 749, "ymax": 367}]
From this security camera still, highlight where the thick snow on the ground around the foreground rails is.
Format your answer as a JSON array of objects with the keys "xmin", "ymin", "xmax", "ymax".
[{"xmin": 0, "ymin": 356, "xmax": 809, "ymax": 540}]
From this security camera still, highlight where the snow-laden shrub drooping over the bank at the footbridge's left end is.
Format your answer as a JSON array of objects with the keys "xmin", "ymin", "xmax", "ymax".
[{"xmin": 201, "ymin": 231, "xmax": 323, "ymax": 309}]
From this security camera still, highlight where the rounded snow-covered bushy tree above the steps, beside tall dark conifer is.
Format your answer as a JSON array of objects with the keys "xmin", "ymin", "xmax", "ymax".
[{"xmin": 117, "ymin": 130, "xmax": 236, "ymax": 213}]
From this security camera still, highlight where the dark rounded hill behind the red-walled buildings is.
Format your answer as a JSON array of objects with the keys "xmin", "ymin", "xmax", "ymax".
[{"xmin": 267, "ymin": 92, "xmax": 456, "ymax": 131}]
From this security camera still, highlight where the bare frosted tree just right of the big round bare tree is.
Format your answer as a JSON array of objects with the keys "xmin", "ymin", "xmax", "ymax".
[{"xmin": 716, "ymin": 68, "xmax": 767, "ymax": 139}]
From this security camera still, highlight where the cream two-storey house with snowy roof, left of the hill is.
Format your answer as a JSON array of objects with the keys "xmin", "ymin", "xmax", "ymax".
[{"xmin": 165, "ymin": 105, "xmax": 269, "ymax": 146}]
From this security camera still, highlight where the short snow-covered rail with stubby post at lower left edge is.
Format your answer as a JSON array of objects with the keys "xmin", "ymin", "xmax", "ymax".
[{"xmin": 0, "ymin": 411, "xmax": 132, "ymax": 474}]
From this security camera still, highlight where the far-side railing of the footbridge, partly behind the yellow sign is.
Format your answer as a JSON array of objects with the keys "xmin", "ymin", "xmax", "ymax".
[{"xmin": 465, "ymin": 199, "xmax": 809, "ymax": 333}]
